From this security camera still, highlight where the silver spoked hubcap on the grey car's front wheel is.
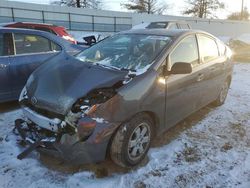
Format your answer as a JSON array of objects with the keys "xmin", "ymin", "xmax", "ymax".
[{"xmin": 128, "ymin": 122, "xmax": 150, "ymax": 160}]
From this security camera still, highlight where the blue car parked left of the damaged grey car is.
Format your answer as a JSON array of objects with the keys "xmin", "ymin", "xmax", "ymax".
[{"xmin": 0, "ymin": 27, "xmax": 85, "ymax": 102}]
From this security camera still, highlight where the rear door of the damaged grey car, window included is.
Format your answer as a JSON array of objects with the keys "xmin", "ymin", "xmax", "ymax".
[{"xmin": 198, "ymin": 34, "xmax": 227, "ymax": 106}]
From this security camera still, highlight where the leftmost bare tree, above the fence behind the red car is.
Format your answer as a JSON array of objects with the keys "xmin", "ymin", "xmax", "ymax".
[{"xmin": 52, "ymin": 0, "xmax": 101, "ymax": 9}]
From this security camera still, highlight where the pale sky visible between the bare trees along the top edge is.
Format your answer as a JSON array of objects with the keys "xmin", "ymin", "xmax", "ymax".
[{"xmin": 5, "ymin": 0, "xmax": 250, "ymax": 18}]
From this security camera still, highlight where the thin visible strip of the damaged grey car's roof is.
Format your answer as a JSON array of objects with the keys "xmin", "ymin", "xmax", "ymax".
[{"xmin": 121, "ymin": 29, "xmax": 211, "ymax": 37}]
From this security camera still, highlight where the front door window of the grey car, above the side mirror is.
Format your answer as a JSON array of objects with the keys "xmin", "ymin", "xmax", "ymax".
[{"xmin": 169, "ymin": 35, "xmax": 199, "ymax": 66}]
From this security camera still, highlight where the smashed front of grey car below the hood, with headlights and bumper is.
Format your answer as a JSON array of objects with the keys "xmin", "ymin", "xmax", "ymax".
[{"xmin": 15, "ymin": 72, "xmax": 127, "ymax": 164}]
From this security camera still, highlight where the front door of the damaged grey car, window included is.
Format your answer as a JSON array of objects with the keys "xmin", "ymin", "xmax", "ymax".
[{"xmin": 166, "ymin": 35, "xmax": 202, "ymax": 127}]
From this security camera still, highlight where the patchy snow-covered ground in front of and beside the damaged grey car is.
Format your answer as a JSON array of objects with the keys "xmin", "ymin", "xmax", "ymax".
[{"xmin": 0, "ymin": 64, "xmax": 250, "ymax": 188}]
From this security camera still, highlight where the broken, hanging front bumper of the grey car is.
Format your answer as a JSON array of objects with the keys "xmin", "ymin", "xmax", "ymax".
[{"xmin": 15, "ymin": 114, "xmax": 116, "ymax": 164}]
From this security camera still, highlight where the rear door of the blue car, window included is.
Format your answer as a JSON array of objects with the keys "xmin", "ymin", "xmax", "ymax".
[{"xmin": 10, "ymin": 33, "xmax": 61, "ymax": 97}]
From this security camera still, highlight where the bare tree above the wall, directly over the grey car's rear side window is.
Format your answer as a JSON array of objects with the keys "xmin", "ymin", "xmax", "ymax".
[{"xmin": 183, "ymin": 0, "xmax": 225, "ymax": 18}]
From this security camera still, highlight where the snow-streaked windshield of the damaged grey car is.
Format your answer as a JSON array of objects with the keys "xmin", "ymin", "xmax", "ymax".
[{"xmin": 77, "ymin": 34, "xmax": 170, "ymax": 71}]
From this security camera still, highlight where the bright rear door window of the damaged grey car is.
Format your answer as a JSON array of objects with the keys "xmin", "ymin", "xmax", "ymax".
[{"xmin": 198, "ymin": 35, "xmax": 219, "ymax": 62}]
